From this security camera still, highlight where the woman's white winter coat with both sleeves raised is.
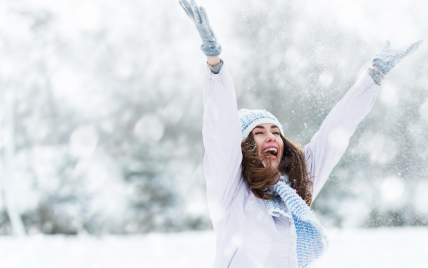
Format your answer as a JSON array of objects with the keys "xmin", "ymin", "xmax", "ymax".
[{"xmin": 202, "ymin": 62, "xmax": 380, "ymax": 268}]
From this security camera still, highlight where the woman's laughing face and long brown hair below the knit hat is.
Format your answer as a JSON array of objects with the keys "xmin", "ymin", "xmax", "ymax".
[{"xmin": 241, "ymin": 118, "xmax": 312, "ymax": 206}]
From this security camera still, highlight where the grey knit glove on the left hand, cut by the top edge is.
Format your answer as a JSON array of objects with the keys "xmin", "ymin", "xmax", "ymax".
[{"xmin": 180, "ymin": 0, "xmax": 221, "ymax": 57}]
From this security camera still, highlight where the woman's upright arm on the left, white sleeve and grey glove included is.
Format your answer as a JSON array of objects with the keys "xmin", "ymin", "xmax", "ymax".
[{"xmin": 180, "ymin": 0, "xmax": 242, "ymax": 224}]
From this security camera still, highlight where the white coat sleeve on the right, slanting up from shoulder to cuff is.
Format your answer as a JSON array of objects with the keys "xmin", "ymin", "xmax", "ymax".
[{"xmin": 303, "ymin": 71, "xmax": 380, "ymax": 200}]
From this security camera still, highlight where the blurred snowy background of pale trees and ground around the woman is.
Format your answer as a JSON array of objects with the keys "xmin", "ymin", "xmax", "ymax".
[{"xmin": 0, "ymin": 0, "xmax": 428, "ymax": 268}]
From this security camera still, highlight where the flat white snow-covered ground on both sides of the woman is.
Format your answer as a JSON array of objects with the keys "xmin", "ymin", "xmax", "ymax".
[{"xmin": 0, "ymin": 227, "xmax": 428, "ymax": 268}]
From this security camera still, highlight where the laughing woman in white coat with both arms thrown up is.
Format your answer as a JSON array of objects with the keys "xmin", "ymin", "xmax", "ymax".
[{"xmin": 180, "ymin": 0, "xmax": 422, "ymax": 268}]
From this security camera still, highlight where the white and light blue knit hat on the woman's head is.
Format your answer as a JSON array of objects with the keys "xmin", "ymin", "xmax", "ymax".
[{"xmin": 238, "ymin": 109, "xmax": 284, "ymax": 140}]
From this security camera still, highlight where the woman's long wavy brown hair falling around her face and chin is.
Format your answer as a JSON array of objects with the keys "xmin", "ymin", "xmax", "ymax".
[{"xmin": 241, "ymin": 133, "xmax": 312, "ymax": 206}]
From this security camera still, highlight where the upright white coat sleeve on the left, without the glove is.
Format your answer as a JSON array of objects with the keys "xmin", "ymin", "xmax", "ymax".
[{"xmin": 202, "ymin": 62, "xmax": 242, "ymax": 225}]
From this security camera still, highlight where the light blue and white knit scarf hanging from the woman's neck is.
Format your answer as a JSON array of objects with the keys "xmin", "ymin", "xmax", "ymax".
[{"xmin": 265, "ymin": 175, "xmax": 328, "ymax": 268}]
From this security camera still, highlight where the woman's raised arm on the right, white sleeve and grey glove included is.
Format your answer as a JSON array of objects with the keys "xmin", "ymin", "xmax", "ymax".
[{"xmin": 303, "ymin": 41, "xmax": 422, "ymax": 199}]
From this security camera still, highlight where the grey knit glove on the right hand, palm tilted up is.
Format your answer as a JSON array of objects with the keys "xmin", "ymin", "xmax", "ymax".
[{"xmin": 373, "ymin": 40, "xmax": 423, "ymax": 75}]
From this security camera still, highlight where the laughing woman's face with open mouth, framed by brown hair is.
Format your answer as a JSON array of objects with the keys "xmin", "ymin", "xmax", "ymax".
[{"xmin": 252, "ymin": 123, "xmax": 284, "ymax": 168}]
